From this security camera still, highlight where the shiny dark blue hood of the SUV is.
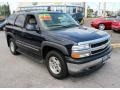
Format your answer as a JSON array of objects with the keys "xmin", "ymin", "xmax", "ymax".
[{"xmin": 49, "ymin": 27, "xmax": 108, "ymax": 43}]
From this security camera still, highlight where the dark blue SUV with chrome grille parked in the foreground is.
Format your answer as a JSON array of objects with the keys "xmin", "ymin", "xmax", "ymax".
[{"xmin": 5, "ymin": 11, "xmax": 111, "ymax": 79}]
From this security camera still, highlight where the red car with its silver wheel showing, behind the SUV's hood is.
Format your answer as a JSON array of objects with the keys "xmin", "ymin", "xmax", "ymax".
[{"xmin": 91, "ymin": 17, "xmax": 115, "ymax": 30}]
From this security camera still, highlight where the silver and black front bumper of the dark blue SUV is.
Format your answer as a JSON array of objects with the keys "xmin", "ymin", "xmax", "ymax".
[{"xmin": 67, "ymin": 48, "xmax": 112, "ymax": 74}]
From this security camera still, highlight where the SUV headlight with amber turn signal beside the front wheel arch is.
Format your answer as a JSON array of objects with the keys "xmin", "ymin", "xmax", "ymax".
[{"xmin": 71, "ymin": 44, "xmax": 90, "ymax": 59}]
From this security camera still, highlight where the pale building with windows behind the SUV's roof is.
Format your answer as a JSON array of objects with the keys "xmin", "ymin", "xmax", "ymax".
[{"xmin": 17, "ymin": 2, "xmax": 85, "ymax": 15}]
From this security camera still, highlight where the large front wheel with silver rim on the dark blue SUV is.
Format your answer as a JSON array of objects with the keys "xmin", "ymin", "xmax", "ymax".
[{"xmin": 46, "ymin": 51, "xmax": 68, "ymax": 79}]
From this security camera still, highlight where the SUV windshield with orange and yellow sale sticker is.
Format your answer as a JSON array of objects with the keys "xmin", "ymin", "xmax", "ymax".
[{"xmin": 38, "ymin": 13, "xmax": 79, "ymax": 30}]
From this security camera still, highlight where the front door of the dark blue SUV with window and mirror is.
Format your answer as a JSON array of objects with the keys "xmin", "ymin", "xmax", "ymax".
[{"xmin": 18, "ymin": 15, "xmax": 44, "ymax": 55}]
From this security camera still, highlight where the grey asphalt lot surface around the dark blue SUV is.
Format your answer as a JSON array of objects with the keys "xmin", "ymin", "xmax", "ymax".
[{"xmin": 0, "ymin": 20, "xmax": 120, "ymax": 88}]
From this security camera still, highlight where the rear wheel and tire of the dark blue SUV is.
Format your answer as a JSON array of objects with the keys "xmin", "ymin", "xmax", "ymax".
[{"xmin": 9, "ymin": 38, "xmax": 19, "ymax": 55}]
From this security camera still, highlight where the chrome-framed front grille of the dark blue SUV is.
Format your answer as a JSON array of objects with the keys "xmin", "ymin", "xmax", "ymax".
[{"xmin": 78, "ymin": 35, "xmax": 110, "ymax": 56}]
